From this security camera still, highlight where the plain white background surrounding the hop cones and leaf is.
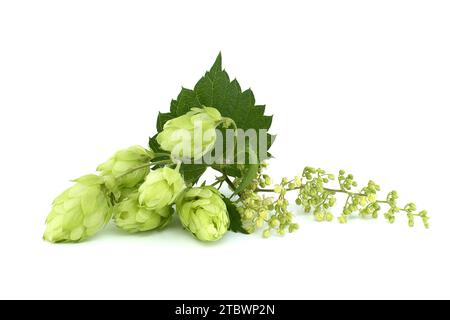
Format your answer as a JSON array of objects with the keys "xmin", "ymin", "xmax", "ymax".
[{"xmin": 0, "ymin": 0, "xmax": 450, "ymax": 299}]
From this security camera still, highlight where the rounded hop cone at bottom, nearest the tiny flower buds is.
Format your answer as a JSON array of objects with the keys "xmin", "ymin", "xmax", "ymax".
[{"xmin": 176, "ymin": 187, "xmax": 230, "ymax": 241}]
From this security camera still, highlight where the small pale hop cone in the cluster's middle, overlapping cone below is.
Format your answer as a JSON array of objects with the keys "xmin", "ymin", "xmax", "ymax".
[{"xmin": 138, "ymin": 167, "xmax": 186, "ymax": 210}]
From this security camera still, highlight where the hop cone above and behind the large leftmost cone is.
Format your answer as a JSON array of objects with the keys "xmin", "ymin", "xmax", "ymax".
[{"xmin": 97, "ymin": 146, "xmax": 154, "ymax": 196}]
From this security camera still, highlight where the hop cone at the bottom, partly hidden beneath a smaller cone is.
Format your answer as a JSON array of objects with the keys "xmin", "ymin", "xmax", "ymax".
[{"xmin": 114, "ymin": 192, "xmax": 173, "ymax": 233}]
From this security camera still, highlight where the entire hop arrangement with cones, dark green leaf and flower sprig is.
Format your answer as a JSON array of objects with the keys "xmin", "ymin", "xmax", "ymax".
[{"xmin": 44, "ymin": 54, "xmax": 429, "ymax": 242}]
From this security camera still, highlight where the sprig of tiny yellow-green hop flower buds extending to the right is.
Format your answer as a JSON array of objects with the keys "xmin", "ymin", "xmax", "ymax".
[{"xmin": 229, "ymin": 165, "xmax": 429, "ymax": 238}]
